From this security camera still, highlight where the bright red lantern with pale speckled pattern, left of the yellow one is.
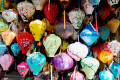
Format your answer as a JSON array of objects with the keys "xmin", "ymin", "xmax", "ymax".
[{"xmin": 16, "ymin": 31, "xmax": 34, "ymax": 54}]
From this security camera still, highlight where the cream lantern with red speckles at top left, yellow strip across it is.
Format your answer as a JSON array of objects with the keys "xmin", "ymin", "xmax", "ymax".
[{"xmin": 17, "ymin": 1, "xmax": 35, "ymax": 22}]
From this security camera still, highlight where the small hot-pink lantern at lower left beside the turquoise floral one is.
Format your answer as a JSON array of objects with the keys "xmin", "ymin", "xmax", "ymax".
[{"xmin": 17, "ymin": 62, "xmax": 30, "ymax": 78}]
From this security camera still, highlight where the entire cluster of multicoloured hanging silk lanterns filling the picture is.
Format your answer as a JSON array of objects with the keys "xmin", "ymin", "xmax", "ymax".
[{"xmin": 0, "ymin": 0, "xmax": 120, "ymax": 80}]
